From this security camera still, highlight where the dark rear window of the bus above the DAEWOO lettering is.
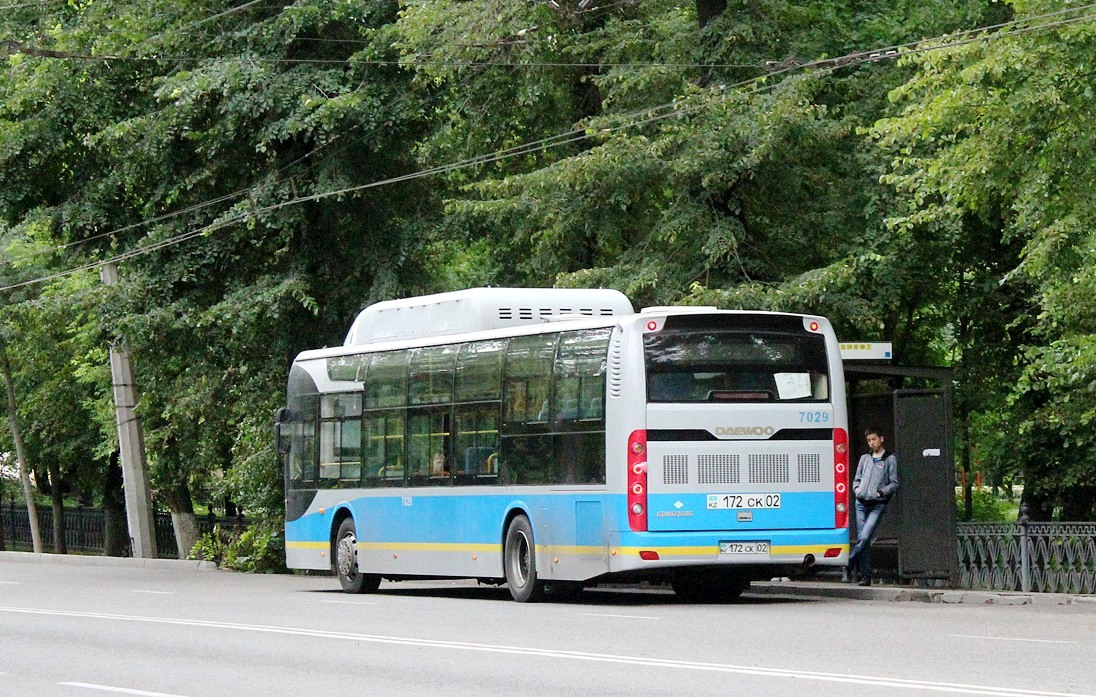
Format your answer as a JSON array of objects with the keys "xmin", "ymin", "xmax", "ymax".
[{"xmin": 643, "ymin": 329, "xmax": 830, "ymax": 402}]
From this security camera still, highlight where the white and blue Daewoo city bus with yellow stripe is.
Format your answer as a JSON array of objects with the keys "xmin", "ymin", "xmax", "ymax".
[{"xmin": 276, "ymin": 288, "xmax": 849, "ymax": 602}]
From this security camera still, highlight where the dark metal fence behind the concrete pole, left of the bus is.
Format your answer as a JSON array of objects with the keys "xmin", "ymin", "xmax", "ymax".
[{"xmin": 0, "ymin": 503, "xmax": 247, "ymax": 559}]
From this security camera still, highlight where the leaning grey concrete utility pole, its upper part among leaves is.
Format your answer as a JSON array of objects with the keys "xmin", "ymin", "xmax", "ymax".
[{"xmin": 99, "ymin": 263, "xmax": 158, "ymax": 559}]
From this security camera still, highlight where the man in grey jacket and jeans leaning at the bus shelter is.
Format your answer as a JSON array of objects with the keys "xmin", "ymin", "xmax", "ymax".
[{"xmin": 841, "ymin": 426, "xmax": 898, "ymax": 585}]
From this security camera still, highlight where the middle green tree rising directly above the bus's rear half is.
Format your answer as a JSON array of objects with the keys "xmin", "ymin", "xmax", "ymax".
[{"xmin": 399, "ymin": 0, "xmax": 982, "ymax": 328}]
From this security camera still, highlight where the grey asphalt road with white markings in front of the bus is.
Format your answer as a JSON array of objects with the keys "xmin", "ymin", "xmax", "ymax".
[{"xmin": 0, "ymin": 558, "xmax": 1096, "ymax": 697}]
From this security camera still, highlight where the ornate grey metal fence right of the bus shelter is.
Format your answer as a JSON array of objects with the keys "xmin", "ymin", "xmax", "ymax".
[{"xmin": 957, "ymin": 522, "xmax": 1096, "ymax": 593}]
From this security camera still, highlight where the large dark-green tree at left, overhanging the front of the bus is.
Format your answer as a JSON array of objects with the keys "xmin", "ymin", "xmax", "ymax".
[{"xmin": 0, "ymin": 2, "xmax": 440, "ymax": 553}]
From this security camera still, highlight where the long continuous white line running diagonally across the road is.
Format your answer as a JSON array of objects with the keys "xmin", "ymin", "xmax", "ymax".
[{"xmin": 0, "ymin": 607, "xmax": 1096, "ymax": 697}]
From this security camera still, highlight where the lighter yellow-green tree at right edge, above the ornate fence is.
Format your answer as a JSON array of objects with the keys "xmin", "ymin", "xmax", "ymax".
[{"xmin": 874, "ymin": 0, "xmax": 1096, "ymax": 519}]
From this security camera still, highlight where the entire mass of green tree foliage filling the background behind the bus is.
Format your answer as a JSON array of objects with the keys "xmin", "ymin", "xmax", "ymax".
[{"xmin": 6, "ymin": 0, "xmax": 1096, "ymax": 568}]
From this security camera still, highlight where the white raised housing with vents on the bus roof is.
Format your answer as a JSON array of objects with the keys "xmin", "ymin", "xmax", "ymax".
[{"xmin": 343, "ymin": 288, "xmax": 635, "ymax": 346}]
